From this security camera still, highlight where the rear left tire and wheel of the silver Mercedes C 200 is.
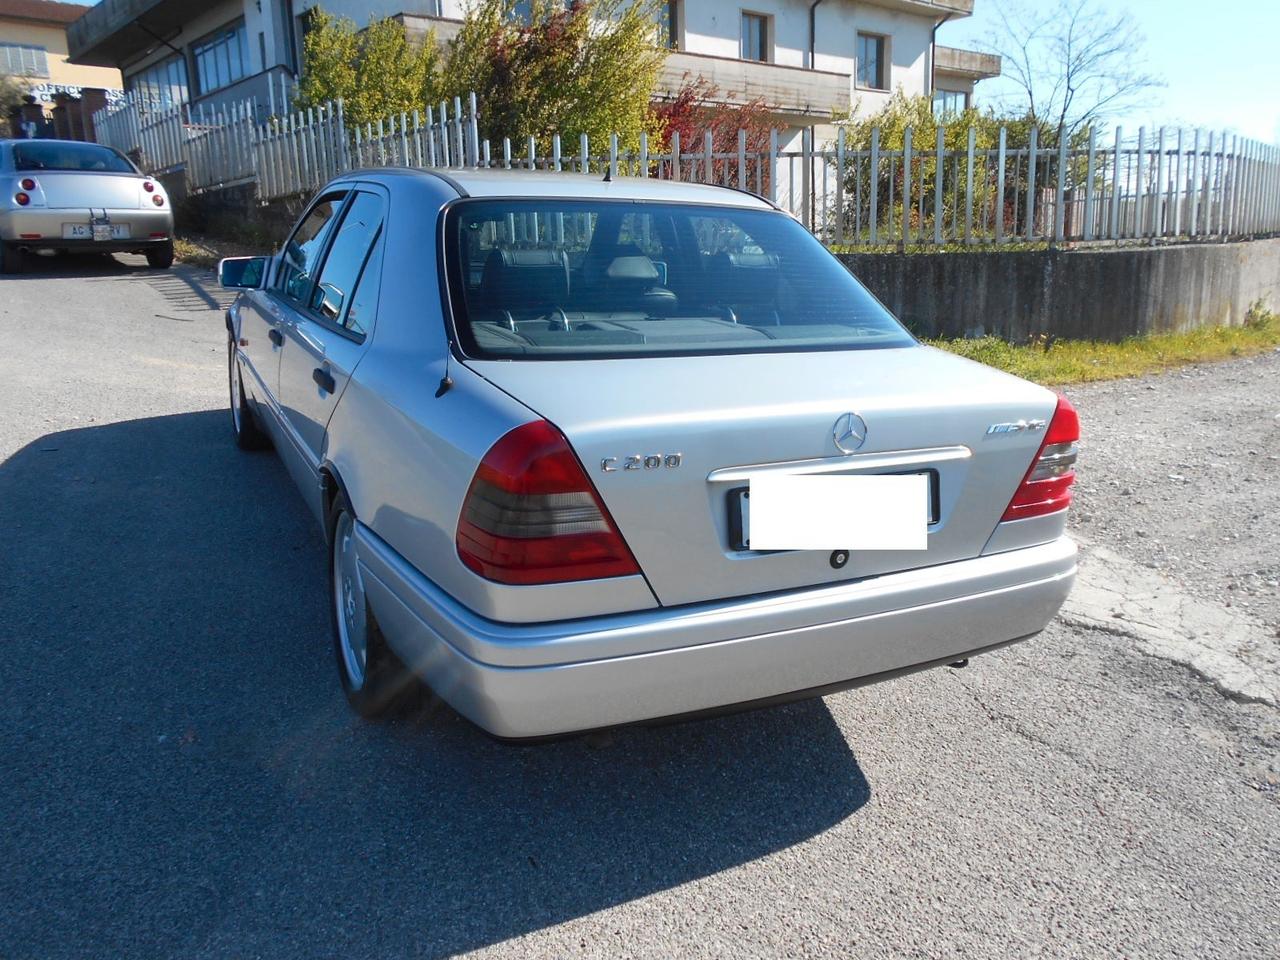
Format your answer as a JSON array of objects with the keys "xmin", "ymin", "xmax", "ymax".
[{"xmin": 329, "ymin": 492, "xmax": 424, "ymax": 719}]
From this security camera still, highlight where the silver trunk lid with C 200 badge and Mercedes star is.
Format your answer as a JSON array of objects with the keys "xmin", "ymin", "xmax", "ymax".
[{"xmin": 468, "ymin": 346, "xmax": 1056, "ymax": 605}]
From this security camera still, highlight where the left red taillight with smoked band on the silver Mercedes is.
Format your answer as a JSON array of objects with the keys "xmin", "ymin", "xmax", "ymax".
[{"xmin": 457, "ymin": 420, "xmax": 640, "ymax": 584}]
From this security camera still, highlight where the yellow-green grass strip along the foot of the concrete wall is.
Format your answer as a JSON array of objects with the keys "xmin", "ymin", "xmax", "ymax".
[{"xmin": 927, "ymin": 303, "xmax": 1280, "ymax": 385}]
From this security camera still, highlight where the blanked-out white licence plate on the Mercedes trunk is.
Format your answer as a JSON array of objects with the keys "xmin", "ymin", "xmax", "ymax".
[{"xmin": 730, "ymin": 471, "xmax": 937, "ymax": 550}]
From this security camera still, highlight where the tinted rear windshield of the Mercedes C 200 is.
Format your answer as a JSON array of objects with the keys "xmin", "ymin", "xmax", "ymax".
[{"xmin": 445, "ymin": 200, "xmax": 914, "ymax": 360}]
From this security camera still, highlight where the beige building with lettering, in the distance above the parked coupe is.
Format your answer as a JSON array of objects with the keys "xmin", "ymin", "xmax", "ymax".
[{"xmin": 0, "ymin": 0, "xmax": 123, "ymax": 113}]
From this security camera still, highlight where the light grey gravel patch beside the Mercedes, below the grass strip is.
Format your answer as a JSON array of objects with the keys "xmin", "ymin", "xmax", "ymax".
[{"xmin": 1065, "ymin": 351, "xmax": 1280, "ymax": 631}]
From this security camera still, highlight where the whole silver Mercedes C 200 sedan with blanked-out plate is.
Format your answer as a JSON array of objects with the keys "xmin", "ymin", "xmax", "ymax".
[{"xmin": 220, "ymin": 170, "xmax": 1079, "ymax": 739}]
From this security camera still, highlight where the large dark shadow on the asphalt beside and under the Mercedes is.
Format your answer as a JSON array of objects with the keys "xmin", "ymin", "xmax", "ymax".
[{"xmin": 0, "ymin": 411, "xmax": 870, "ymax": 956}]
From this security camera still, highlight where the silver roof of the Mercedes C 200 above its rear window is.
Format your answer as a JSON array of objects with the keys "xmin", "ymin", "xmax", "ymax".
[{"xmin": 339, "ymin": 166, "xmax": 774, "ymax": 209}]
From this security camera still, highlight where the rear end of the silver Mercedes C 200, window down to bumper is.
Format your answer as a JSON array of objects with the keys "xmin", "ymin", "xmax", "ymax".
[{"xmin": 360, "ymin": 188, "xmax": 1079, "ymax": 737}]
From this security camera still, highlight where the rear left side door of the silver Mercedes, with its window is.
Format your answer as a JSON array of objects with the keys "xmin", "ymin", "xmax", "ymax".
[{"xmin": 279, "ymin": 187, "xmax": 387, "ymax": 483}]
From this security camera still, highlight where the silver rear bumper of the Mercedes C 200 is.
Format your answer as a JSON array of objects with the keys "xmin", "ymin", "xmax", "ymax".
[{"xmin": 358, "ymin": 527, "xmax": 1075, "ymax": 737}]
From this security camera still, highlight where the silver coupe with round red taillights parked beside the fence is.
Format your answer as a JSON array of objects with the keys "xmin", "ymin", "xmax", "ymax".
[{"xmin": 0, "ymin": 140, "xmax": 173, "ymax": 274}]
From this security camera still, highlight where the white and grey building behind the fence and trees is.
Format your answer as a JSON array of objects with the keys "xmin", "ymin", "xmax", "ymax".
[{"xmin": 67, "ymin": 0, "xmax": 1000, "ymax": 146}]
